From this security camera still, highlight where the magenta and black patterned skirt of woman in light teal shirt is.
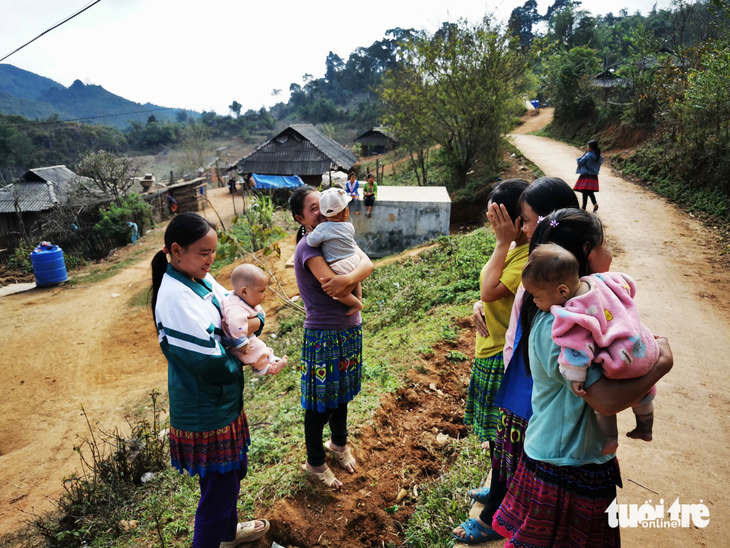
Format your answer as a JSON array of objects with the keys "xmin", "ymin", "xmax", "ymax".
[{"xmin": 492, "ymin": 455, "xmax": 621, "ymax": 548}]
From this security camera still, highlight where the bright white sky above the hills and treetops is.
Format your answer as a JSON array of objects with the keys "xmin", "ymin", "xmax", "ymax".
[{"xmin": 0, "ymin": 0, "xmax": 668, "ymax": 114}]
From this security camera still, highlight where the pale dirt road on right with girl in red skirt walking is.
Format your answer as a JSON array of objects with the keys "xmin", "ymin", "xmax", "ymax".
[{"xmin": 512, "ymin": 127, "xmax": 730, "ymax": 548}]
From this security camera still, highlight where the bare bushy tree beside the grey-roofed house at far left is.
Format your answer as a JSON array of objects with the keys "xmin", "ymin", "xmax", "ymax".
[{"xmin": 76, "ymin": 150, "xmax": 141, "ymax": 205}]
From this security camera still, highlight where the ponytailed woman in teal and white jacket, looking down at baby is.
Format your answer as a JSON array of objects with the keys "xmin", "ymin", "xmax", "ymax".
[{"xmin": 152, "ymin": 213, "xmax": 269, "ymax": 548}]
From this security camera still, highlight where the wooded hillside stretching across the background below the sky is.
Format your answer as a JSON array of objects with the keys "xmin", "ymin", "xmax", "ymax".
[{"xmin": 0, "ymin": 0, "xmax": 730, "ymax": 216}]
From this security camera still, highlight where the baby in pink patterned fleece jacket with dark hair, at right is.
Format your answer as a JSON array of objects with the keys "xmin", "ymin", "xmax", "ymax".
[{"xmin": 522, "ymin": 244, "xmax": 659, "ymax": 455}]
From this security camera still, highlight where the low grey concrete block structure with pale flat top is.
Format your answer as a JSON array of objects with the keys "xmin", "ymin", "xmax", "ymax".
[{"xmin": 350, "ymin": 186, "xmax": 451, "ymax": 257}]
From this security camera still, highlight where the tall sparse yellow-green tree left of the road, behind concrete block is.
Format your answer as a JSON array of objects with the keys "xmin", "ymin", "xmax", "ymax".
[{"xmin": 380, "ymin": 18, "xmax": 529, "ymax": 186}]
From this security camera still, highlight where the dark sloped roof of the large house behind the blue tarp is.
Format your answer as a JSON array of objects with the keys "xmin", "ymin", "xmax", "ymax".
[{"xmin": 236, "ymin": 124, "xmax": 358, "ymax": 175}]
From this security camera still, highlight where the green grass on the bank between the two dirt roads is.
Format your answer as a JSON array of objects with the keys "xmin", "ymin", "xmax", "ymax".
[{"xmin": 12, "ymin": 229, "xmax": 494, "ymax": 548}]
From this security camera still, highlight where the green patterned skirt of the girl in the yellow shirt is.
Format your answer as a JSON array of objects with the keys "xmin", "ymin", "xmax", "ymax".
[{"xmin": 464, "ymin": 352, "xmax": 504, "ymax": 441}]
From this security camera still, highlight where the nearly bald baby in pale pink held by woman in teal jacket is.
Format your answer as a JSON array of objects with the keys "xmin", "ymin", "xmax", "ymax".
[{"xmin": 221, "ymin": 264, "xmax": 287, "ymax": 375}]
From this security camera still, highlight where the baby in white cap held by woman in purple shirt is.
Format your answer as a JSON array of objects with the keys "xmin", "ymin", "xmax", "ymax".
[{"xmin": 307, "ymin": 188, "xmax": 362, "ymax": 316}]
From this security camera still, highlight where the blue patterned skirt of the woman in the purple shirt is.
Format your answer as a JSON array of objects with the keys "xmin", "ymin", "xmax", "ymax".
[{"xmin": 301, "ymin": 325, "xmax": 362, "ymax": 413}]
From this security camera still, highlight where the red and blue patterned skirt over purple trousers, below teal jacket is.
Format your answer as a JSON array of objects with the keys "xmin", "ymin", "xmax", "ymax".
[{"xmin": 170, "ymin": 410, "xmax": 251, "ymax": 478}]
